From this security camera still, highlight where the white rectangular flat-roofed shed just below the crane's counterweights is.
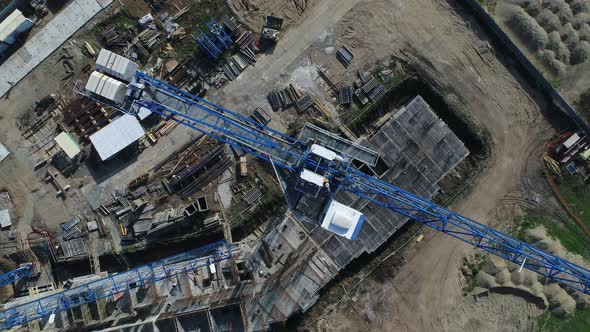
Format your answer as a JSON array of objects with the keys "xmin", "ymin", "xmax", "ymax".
[{"xmin": 90, "ymin": 114, "xmax": 145, "ymax": 160}]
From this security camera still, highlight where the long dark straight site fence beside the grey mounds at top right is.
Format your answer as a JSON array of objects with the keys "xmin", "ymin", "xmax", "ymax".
[{"xmin": 459, "ymin": 0, "xmax": 590, "ymax": 135}]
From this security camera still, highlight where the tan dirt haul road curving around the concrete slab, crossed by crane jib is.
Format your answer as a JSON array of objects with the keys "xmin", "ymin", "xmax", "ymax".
[{"xmin": 221, "ymin": 0, "xmax": 553, "ymax": 331}]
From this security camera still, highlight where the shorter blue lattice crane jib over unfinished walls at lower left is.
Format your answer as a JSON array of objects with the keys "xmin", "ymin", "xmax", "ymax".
[{"xmin": 0, "ymin": 241, "xmax": 232, "ymax": 330}]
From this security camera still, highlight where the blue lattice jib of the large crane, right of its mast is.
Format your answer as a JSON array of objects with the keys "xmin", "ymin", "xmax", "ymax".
[{"xmin": 343, "ymin": 169, "xmax": 590, "ymax": 294}]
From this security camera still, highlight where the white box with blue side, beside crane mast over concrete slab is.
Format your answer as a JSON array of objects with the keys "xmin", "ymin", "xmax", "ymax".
[{"xmin": 322, "ymin": 200, "xmax": 365, "ymax": 240}]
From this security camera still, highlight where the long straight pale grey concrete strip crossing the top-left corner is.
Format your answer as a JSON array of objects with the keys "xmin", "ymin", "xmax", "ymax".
[{"xmin": 0, "ymin": 0, "xmax": 112, "ymax": 97}]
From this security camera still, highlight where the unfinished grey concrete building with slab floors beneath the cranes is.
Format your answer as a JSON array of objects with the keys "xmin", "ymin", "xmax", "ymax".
[{"xmin": 0, "ymin": 96, "xmax": 468, "ymax": 331}]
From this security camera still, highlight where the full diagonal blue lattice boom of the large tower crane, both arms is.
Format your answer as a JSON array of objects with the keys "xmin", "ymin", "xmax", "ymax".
[{"xmin": 132, "ymin": 72, "xmax": 590, "ymax": 294}]
